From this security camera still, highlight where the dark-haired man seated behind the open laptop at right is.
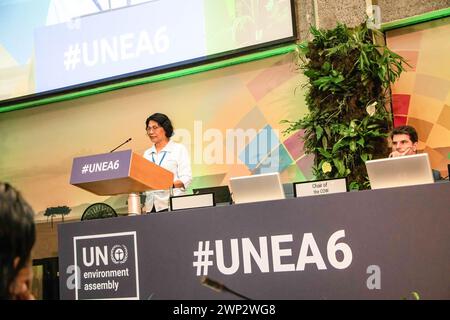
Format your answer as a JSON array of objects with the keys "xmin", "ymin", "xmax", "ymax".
[{"xmin": 389, "ymin": 126, "xmax": 442, "ymax": 181}]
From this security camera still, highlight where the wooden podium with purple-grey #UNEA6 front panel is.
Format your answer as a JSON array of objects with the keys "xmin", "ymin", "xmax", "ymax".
[{"xmin": 70, "ymin": 150, "xmax": 173, "ymax": 213}]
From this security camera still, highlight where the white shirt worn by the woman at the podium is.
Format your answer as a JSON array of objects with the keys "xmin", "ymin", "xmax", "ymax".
[{"xmin": 144, "ymin": 140, "xmax": 192, "ymax": 212}]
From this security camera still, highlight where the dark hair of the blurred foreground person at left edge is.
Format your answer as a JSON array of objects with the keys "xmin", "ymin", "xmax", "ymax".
[{"xmin": 0, "ymin": 182, "xmax": 36, "ymax": 300}]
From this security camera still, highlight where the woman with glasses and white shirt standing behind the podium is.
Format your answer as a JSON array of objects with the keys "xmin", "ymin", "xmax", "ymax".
[{"xmin": 144, "ymin": 113, "xmax": 192, "ymax": 213}]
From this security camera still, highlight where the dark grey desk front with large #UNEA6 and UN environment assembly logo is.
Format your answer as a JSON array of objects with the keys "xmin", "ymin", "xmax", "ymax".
[{"xmin": 58, "ymin": 183, "xmax": 450, "ymax": 300}]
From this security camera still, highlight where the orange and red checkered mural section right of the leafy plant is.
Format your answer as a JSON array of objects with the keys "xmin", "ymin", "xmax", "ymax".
[{"xmin": 386, "ymin": 17, "xmax": 450, "ymax": 177}]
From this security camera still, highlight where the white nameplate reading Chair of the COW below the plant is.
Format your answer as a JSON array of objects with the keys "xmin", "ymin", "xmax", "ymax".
[{"xmin": 294, "ymin": 178, "xmax": 347, "ymax": 198}]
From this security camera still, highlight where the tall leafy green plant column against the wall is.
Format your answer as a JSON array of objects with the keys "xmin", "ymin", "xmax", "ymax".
[{"xmin": 283, "ymin": 24, "xmax": 406, "ymax": 189}]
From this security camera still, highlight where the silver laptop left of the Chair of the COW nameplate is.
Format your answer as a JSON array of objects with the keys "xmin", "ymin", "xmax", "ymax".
[{"xmin": 230, "ymin": 172, "xmax": 286, "ymax": 203}]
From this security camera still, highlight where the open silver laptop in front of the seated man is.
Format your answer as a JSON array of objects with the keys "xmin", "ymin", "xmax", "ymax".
[{"xmin": 366, "ymin": 153, "xmax": 434, "ymax": 189}]
